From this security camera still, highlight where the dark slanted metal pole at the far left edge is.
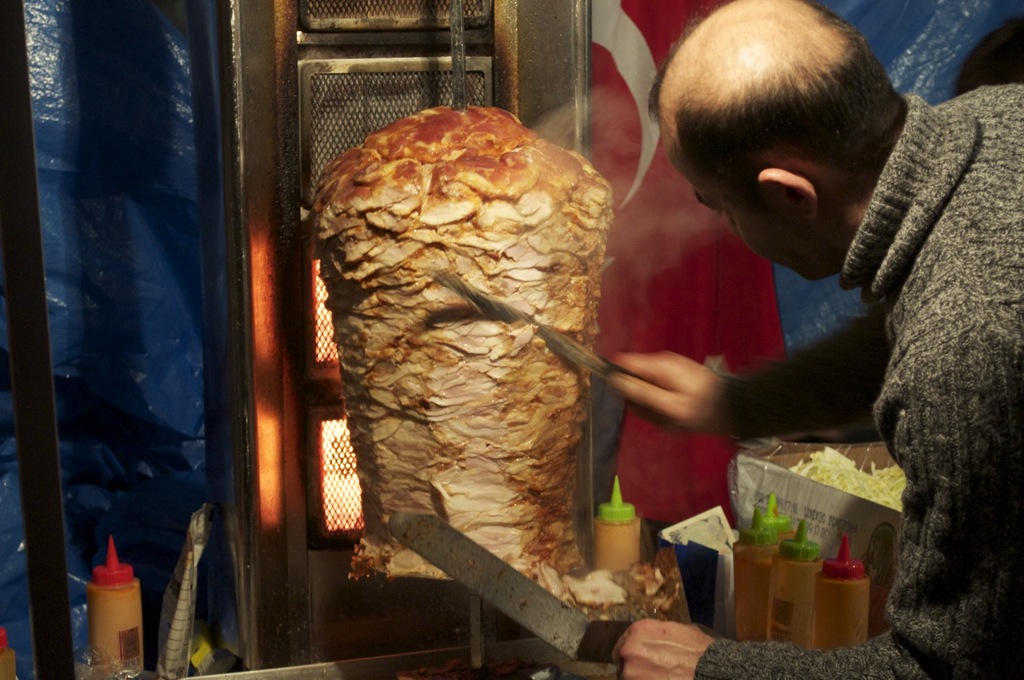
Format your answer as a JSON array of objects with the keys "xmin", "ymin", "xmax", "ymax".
[{"xmin": 0, "ymin": 0, "xmax": 75, "ymax": 680}]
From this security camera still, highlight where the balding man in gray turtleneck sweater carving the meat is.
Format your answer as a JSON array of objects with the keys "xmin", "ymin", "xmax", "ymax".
[{"xmin": 612, "ymin": 0, "xmax": 1024, "ymax": 678}]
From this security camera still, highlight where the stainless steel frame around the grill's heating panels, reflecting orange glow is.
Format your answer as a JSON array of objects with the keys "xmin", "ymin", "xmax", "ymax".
[{"xmin": 207, "ymin": 0, "xmax": 590, "ymax": 667}]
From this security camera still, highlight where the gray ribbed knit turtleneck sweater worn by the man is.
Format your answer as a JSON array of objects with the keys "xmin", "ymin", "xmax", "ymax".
[{"xmin": 696, "ymin": 86, "xmax": 1024, "ymax": 679}]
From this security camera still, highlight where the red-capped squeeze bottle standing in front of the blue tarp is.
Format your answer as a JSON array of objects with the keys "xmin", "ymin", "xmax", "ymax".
[{"xmin": 85, "ymin": 536, "xmax": 143, "ymax": 673}]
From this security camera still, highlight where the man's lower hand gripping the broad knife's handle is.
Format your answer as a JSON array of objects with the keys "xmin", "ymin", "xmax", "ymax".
[{"xmin": 612, "ymin": 619, "xmax": 713, "ymax": 680}]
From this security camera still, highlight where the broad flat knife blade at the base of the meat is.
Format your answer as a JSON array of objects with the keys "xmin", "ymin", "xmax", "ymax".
[{"xmin": 388, "ymin": 512, "xmax": 632, "ymax": 664}]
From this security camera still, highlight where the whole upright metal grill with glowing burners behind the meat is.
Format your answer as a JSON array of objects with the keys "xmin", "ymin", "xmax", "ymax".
[{"xmin": 201, "ymin": 0, "xmax": 592, "ymax": 677}]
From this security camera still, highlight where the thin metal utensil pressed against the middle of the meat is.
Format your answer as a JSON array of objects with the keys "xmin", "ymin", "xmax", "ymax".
[{"xmin": 432, "ymin": 271, "xmax": 639, "ymax": 380}]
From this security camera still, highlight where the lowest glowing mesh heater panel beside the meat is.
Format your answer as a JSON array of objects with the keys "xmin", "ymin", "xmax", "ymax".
[{"xmin": 319, "ymin": 419, "xmax": 364, "ymax": 537}]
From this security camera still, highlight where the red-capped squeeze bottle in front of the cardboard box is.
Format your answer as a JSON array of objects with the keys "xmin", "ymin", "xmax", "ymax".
[{"xmin": 814, "ymin": 534, "xmax": 871, "ymax": 649}]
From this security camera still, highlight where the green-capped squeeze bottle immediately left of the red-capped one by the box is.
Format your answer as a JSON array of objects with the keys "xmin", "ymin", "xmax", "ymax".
[{"xmin": 768, "ymin": 519, "xmax": 821, "ymax": 648}]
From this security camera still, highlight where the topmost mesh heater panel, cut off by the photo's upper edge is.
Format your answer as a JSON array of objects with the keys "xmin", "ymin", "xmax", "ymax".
[{"xmin": 303, "ymin": 0, "xmax": 490, "ymax": 30}]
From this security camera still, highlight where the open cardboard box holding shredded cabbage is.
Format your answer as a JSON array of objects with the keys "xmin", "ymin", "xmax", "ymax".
[{"xmin": 729, "ymin": 442, "xmax": 902, "ymax": 636}]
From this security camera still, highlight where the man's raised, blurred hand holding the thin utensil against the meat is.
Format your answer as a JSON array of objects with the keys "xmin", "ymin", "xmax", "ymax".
[{"xmin": 608, "ymin": 352, "xmax": 730, "ymax": 434}]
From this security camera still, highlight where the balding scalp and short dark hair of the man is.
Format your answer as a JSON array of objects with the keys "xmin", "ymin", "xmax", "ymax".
[{"xmin": 651, "ymin": 0, "xmax": 904, "ymax": 200}]
